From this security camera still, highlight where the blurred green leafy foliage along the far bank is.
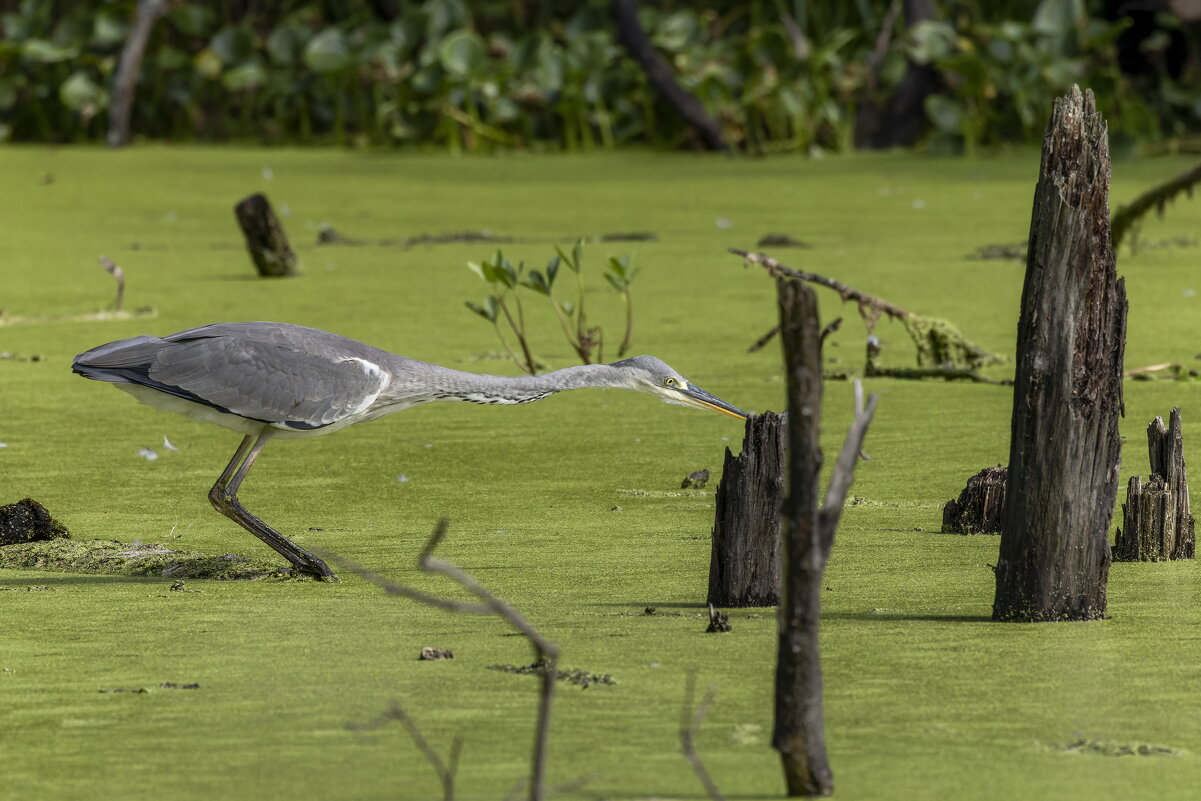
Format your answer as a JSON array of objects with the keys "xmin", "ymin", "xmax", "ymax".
[{"xmin": 0, "ymin": 0, "xmax": 1201, "ymax": 153}]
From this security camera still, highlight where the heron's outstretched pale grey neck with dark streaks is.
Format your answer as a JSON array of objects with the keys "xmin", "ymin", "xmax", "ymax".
[{"xmin": 393, "ymin": 364, "xmax": 635, "ymax": 405}]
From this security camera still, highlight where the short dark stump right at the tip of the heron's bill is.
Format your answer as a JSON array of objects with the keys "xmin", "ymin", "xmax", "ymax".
[{"xmin": 707, "ymin": 412, "xmax": 788, "ymax": 608}]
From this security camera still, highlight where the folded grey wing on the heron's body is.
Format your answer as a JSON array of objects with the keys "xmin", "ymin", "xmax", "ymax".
[{"xmin": 147, "ymin": 336, "xmax": 388, "ymax": 429}]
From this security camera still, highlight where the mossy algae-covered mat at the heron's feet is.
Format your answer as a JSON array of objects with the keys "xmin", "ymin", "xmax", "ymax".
[{"xmin": 0, "ymin": 539, "xmax": 292, "ymax": 581}]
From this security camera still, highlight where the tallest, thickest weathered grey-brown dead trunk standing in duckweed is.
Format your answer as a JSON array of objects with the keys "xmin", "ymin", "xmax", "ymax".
[{"xmin": 992, "ymin": 86, "xmax": 1127, "ymax": 621}]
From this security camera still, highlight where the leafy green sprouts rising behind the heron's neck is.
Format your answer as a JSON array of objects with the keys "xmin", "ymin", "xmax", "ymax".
[{"xmin": 467, "ymin": 240, "xmax": 638, "ymax": 375}]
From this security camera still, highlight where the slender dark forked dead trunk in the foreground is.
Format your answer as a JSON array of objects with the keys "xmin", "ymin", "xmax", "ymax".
[{"xmin": 771, "ymin": 279, "xmax": 876, "ymax": 797}]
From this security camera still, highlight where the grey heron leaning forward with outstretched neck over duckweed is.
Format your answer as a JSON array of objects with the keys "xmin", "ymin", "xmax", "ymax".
[{"xmin": 71, "ymin": 322, "xmax": 746, "ymax": 580}]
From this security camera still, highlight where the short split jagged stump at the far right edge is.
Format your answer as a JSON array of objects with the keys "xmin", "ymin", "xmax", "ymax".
[{"xmin": 1113, "ymin": 408, "xmax": 1196, "ymax": 562}]
